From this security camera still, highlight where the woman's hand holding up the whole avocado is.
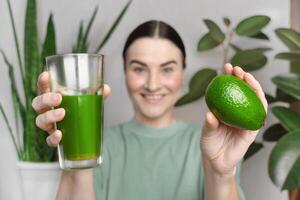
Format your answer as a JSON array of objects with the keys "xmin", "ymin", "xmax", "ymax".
[{"xmin": 200, "ymin": 64, "xmax": 268, "ymax": 175}]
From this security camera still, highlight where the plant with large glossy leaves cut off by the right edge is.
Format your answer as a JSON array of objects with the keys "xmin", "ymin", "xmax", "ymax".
[{"xmin": 263, "ymin": 28, "xmax": 300, "ymax": 200}]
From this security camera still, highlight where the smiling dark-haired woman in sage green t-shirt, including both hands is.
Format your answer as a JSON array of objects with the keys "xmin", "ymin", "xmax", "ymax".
[{"xmin": 32, "ymin": 21, "xmax": 267, "ymax": 200}]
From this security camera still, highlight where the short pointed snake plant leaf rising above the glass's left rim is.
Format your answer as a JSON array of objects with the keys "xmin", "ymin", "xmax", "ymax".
[{"xmin": 41, "ymin": 13, "xmax": 56, "ymax": 66}]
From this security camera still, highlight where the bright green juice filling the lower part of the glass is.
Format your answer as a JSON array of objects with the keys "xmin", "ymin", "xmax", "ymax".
[{"xmin": 57, "ymin": 95, "xmax": 102, "ymax": 161}]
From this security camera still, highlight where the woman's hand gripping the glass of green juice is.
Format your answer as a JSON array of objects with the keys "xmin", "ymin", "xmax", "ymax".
[{"xmin": 32, "ymin": 71, "xmax": 110, "ymax": 147}]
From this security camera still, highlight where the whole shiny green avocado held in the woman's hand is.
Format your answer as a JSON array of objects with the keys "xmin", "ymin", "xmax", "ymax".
[{"xmin": 205, "ymin": 75, "xmax": 266, "ymax": 130}]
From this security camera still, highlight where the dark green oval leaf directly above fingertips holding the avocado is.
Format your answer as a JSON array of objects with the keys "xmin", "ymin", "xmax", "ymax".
[{"xmin": 231, "ymin": 49, "xmax": 267, "ymax": 72}]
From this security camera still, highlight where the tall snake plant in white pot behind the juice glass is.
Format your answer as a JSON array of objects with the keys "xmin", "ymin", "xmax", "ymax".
[{"xmin": 0, "ymin": 0, "xmax": 131, "ymax": 200}]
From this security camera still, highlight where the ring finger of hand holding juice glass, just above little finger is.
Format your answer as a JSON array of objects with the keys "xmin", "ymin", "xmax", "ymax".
[{"xmin": 35, "ymin": 108, "xmax": 65, "ymax": 132}]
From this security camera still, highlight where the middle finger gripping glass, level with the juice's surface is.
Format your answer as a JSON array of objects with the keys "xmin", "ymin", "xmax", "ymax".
[{"xmin": 32, "ymin": 92, "xmax": 62, "ymax": 113}]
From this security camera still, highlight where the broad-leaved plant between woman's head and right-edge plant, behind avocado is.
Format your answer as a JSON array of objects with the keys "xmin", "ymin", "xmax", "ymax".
[{"xmin": 176, "ymin": 15, "xmax": 271, "ymax": 160}]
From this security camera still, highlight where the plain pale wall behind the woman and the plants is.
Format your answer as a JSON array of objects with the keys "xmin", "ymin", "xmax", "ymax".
[{"xmin": 0, "ymin": 0, "xmax": 289, "ymax": 200}]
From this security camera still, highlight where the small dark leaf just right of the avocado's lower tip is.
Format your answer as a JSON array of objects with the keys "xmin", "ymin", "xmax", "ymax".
[{"xmin": 263, "ymin": 124, "xmax": 287, "ymax": 142}]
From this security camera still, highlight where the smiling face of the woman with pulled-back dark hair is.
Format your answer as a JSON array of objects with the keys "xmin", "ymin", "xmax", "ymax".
[{"xmin": 125, "ymin": 38, "xmax": 184, "ymax": 120}]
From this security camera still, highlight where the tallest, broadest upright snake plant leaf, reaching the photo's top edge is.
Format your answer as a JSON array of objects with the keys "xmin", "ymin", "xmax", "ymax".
[{"xmin": 23, "ymin": 0, "xmax": 41, "ymax": 161}]
